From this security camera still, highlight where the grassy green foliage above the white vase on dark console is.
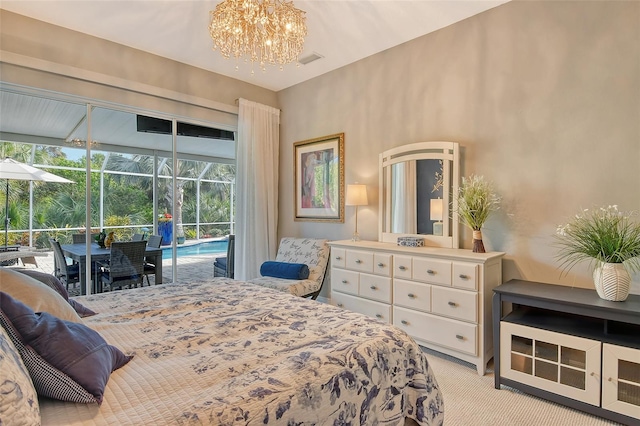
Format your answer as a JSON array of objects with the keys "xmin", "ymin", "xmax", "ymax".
[{"xmin": 555, "ymin": 205, "xmax": 640, "ymax": 273}]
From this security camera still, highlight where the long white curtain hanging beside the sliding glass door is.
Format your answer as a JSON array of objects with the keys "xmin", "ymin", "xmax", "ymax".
[{"xmin": 234, "ymin": 99, "xmax": 280, "ymax": 280}]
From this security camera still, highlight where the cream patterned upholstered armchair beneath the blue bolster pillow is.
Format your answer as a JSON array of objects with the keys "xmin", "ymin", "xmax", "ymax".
[{"xmin": 249, "ymin": 237, "xmax": 330, "ymax": 300}]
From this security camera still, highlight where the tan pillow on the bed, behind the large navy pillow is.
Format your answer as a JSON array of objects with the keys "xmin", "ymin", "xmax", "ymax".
[{"xmin": 0, "ymin": 268, "xmax": 82, "ymax": 323}]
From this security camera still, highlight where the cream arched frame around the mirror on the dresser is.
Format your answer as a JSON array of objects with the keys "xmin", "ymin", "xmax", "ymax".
[{"xmin": 378, "ymin": 141, "xmax": 460, "ymax": 248}]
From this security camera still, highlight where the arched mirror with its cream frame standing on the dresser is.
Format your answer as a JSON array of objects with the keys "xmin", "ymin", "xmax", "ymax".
[{"xmin": 379, "ymin": 142, "xmax": 460, "ymax": 248}]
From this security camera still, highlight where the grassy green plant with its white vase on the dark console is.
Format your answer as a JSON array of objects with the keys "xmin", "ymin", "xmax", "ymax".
[{"xmin": 556, "ymin": 205, "xmax": 640, "ymax": 301}]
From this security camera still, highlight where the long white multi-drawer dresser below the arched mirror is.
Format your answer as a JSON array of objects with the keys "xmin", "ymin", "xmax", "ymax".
[{"xmin": 329, "ymin": 240, "xmax": 504, "ymax": 375}]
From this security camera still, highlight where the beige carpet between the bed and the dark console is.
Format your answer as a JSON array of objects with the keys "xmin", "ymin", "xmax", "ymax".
[{"xmin": 424, "ymin": 349, "xmax": 618, "ymax": 426}]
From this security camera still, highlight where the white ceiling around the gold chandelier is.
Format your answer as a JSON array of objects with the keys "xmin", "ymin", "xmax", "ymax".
[{"xmin": 0, "ymin": 0, "xmax": 509, "ymax": 91}]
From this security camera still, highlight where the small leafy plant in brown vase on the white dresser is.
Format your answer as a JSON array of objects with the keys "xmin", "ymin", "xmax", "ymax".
[{"xmin": 458, "ymin": 175, "xmax": 500, "ymax": 253}]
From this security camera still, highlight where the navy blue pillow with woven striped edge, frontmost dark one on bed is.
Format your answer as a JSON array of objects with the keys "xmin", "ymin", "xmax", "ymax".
[{"xmin": 0, "ymin": 292, "xmax": 133, "ymax": 404}]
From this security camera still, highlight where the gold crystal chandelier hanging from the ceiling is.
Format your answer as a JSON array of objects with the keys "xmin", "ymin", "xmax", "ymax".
[{"xmin": 209, "ymin": 0, "xmax": 307, "ymax": 74}]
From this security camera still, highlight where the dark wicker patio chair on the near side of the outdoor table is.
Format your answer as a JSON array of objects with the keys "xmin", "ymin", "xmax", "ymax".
[{"xmin": 94, "ymin": 241, "xmax": 147, "ymax": 293}]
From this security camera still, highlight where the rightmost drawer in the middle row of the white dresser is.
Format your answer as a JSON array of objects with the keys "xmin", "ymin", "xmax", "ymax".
[{"xmin": 431, "ymin": 286, "xmax": 478, "ymax": 323}]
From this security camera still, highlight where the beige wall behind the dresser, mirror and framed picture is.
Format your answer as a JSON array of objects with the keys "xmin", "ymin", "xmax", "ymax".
[{"xmin": 278, "ymin": 1, "xmax": 640, "ymax": 296}]
